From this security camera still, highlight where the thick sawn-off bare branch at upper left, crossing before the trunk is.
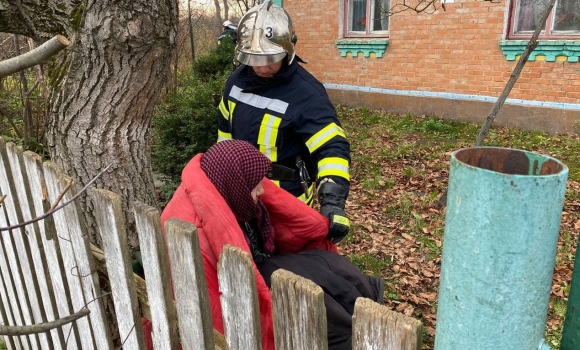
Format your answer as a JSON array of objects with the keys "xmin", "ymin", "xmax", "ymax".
[{"xmin": 0, "ymin": 35, "xmax": 70, "ymax": 77}]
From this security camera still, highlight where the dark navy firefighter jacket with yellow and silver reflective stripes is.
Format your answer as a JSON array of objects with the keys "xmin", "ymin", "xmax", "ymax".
[{"xmin": 218, "ymin": 57, "xmax": 350, "ymax": 205}]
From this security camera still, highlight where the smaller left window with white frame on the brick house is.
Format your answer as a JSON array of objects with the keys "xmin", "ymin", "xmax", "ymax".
[{"xmin": 344, "ymin": 0, "xmax": 390, "ymax": 37}]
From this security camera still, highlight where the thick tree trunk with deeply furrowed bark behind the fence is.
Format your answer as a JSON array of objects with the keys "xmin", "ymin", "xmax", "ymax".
[{"xmin": 0, "ymin": 0, "xmax": 178, "ymax": 252}]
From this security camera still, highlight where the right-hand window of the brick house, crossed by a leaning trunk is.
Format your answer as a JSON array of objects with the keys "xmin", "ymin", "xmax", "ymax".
[{"xmin": 509, "ymin": 0, "xmax": 580, "ymax": 40}]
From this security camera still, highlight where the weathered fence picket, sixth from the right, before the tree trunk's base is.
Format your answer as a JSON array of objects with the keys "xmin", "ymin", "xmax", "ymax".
[{"xmin": 91, "ymin": 189, "xmax": 145, "ymax": 350}]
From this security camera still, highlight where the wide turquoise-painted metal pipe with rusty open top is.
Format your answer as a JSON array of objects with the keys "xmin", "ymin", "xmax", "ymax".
[{"xmin": 435, "ymin": 147, "xmax": 568, "ymax": 350}]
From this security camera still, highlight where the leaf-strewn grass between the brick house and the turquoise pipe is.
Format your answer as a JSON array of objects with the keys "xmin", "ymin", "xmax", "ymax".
[{"xmin": 336, "ymin": 106, "xmax": 580, "ymax": 349}]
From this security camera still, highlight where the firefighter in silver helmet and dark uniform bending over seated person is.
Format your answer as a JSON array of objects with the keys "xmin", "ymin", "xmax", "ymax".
[{"xmin": 218, "ymin": 1, "xmax": 350, "ymax": 242}]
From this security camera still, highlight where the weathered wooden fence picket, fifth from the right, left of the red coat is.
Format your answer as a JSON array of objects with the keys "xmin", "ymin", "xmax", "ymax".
[{"xmin": 133, "ymin": 202, "xmax": 179, "ymax": 350}]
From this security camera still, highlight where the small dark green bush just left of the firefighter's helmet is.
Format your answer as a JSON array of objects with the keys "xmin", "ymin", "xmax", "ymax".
[{"xmin": 193, "ymin": 36, "xmax": 235, "ymax": 82}]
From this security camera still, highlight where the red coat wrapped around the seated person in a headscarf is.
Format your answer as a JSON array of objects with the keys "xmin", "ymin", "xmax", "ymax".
[{"xmin": 161, "ymin": 154, "xmax": 338, "ymax": 350}]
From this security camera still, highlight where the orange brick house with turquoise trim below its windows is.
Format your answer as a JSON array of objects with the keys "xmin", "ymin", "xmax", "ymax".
[{"xmin": 274, "ymin": 0, "xmax": 580, "ymax": 132}]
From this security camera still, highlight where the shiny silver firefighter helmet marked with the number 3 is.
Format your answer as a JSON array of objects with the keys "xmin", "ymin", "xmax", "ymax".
[{"xmin": 236, "ymin": 0, "xmax": 297, "ymax": 66}]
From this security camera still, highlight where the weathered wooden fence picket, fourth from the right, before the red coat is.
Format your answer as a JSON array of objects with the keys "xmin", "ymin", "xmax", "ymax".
[{"xmin": 165, "ymin": 219, "xmax": 215, "ymax": 350}]
